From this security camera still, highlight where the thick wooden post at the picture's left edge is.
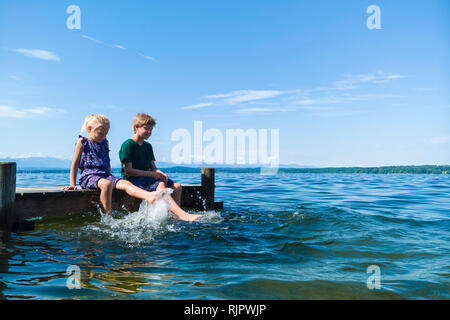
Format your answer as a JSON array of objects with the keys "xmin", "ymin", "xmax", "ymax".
[{"xmin": 0, "ymin": 162, "xmax": 16, "ymax": 230}]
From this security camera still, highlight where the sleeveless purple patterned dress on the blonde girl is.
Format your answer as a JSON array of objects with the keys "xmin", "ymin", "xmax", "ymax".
[{"xmin": 79, "ymin": 136, "xmax": 121, "ymax": 189}]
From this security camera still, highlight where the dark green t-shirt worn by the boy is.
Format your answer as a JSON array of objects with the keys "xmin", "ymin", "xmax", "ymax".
[{"xmin": 119, "ymin": 139, "xmax": 155, "ymax": 179}]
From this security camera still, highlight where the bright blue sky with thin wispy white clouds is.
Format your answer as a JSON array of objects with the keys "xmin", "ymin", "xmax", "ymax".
[{"xmin": 0, "ymin": 0, "xmax": 450, "ymax": 166}]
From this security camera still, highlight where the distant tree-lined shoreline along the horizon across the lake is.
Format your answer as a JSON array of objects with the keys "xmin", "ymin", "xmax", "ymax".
[{"xmin": 12, "ymin": 165, "xmax": 450, "ymax": 174}]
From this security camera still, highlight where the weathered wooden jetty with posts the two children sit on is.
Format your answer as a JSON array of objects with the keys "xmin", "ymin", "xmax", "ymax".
[{"xmin": 0, "ymin": 162, "xmax": 223, "ymax": 230}]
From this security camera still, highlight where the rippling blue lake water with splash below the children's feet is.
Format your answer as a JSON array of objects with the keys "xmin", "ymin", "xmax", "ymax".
[{"xmin": 0, "ymin": 172, "xmax": 450, "ymax": 299}]
